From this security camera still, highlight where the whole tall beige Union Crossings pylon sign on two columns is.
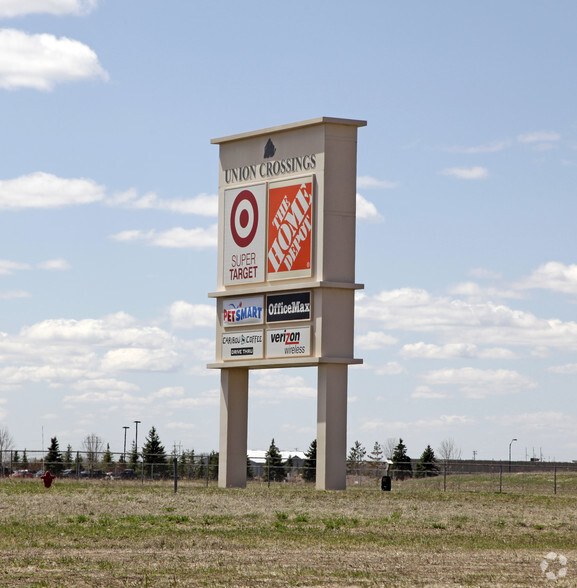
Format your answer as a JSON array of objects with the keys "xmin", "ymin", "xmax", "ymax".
[{"xmin": 208, "ymin": 117, "xmax": 366, "ymax": 490}]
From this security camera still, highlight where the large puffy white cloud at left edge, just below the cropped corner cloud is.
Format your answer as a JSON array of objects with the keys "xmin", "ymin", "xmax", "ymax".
[{"xmin": 0, "ymin": 29, "xmax": 108, "ymax": 90}]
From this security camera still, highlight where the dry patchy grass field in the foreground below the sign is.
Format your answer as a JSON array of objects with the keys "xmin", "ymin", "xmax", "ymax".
[{"xmin": 0, "ymin": 480, "xmax": 577, "ymax": 586}]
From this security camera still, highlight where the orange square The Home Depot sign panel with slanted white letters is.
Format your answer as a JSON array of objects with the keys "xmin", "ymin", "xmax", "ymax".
[{"xmin": 267, "ymin": 180, "xmax": 312, "ymax": 275}]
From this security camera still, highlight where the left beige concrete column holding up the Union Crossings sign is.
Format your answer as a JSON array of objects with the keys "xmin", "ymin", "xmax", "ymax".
[{"xmin": 218, "ymin": 368, "xmax": 248, "ymax": 488}]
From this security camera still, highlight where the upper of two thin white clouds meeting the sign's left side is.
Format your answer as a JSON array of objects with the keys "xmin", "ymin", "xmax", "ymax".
[{"xmin": 107, "ymin": 189, "xmax": 218, "ymax": 217}]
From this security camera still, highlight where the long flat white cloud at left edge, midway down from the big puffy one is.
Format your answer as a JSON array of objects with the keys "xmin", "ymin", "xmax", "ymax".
[{"xmin": 0, "ymin": 171, "xmax": 104, "ymax": 210}]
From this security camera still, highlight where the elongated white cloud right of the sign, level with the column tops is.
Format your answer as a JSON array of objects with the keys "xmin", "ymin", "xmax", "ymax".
[{"xmin": 423, "ymin": 367, "xmax": 537, "ymax": 398}]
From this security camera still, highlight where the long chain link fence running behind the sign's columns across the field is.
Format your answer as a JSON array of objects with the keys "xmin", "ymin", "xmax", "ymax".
[{"xmin": 0, "ymin": 450, "xmax": 577, "ymax": 494}]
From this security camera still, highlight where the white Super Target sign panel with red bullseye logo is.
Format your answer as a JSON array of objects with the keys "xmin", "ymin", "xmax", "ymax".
[{"xmin": 223, "ymin": 184, "xmax": 266, "ymax": 286}]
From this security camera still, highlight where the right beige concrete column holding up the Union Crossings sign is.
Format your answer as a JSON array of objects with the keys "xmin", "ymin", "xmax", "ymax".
[{"xmin": 316, "ymin": 363, "xmax": 348, "ymax": 490}]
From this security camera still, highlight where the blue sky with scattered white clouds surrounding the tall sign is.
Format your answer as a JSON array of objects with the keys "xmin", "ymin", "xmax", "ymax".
[{"xmin": 0, "ymin": 0, "xmax": 577, "ymax": 460}]
